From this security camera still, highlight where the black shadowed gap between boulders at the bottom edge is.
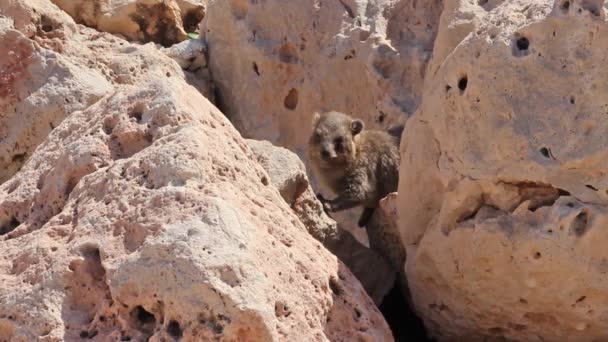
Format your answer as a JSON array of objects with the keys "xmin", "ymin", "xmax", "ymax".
[{"xmin": 379, "ymin": 283, "xmax": 434, "ymax": 342}]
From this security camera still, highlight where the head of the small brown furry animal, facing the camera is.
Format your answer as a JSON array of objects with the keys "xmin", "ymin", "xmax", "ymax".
[{"xmin": 308, "ymin": 111, "xmax": 364, "ymax": 167}]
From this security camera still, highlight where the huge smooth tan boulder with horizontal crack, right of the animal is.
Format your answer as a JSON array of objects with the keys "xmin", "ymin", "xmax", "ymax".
[{"xmin": 398, "ymin": 0, "xmax": 608, "ymax": 341}]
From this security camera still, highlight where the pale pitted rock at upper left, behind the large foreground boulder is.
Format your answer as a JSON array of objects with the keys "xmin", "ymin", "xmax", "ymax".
[{"xmin": 0, "ymin": 0, "xmax": 212, "ymax": 183}]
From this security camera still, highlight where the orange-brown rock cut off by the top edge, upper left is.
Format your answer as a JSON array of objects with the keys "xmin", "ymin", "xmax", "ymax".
[{"xmin": 52, "ymin": 0, "xmax": 207, "ymax": 47}]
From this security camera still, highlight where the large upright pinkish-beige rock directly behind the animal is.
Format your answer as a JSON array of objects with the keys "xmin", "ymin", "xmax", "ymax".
[{"xmin": 201, "ymin": 0, "xmax": 442, "ymax": 238}]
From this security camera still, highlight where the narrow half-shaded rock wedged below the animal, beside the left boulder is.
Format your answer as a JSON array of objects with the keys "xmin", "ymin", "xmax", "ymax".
[{"xmin": 247, "ymin": 139, "xmax": 394, "ymax": 305}]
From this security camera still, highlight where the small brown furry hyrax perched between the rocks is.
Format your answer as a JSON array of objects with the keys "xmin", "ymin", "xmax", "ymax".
[{"xmin": 308, "ymin": 111, "xmax": 400, "ymax": 227}]
